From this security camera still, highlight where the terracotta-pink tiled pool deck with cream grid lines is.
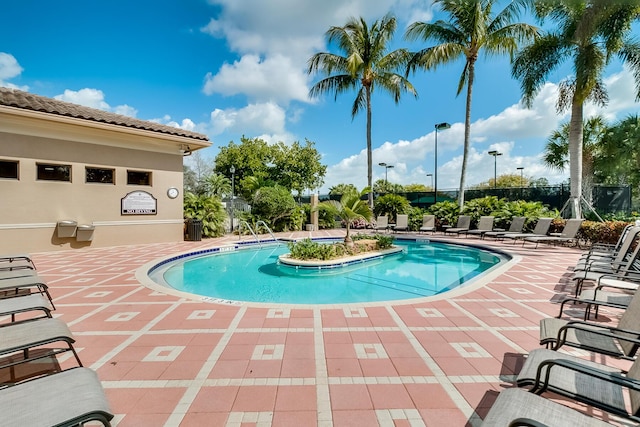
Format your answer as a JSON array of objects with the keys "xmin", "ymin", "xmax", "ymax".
[{"xmin": 2, "ymin": 230, "xmax": 628, "ymax": 427}]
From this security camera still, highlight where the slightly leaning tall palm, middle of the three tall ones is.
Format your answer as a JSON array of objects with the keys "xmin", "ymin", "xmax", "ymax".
[{"xmin": 405, "ymin": 0, "xmax": 538, "ymax": 209}]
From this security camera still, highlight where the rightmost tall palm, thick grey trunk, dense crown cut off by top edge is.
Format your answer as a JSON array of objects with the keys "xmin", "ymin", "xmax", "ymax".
[{"xmin": 512, "ymin": 0, "xmax": 640, "ymax": 218}]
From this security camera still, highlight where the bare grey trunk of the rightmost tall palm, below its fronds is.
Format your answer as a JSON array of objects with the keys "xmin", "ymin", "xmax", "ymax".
[{"xmin": 569, "ymin": 96, "xmax": 583, "ymax": 218}]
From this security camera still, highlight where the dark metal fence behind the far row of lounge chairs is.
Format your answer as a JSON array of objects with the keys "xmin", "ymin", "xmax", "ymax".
[{"xmin": 300, "ymin": 185, "xmax": 631, "ymax": 214}]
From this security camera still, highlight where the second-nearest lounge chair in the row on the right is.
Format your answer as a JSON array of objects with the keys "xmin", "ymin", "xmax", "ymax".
[{"xmin": 516, "ymin": 348, "xmax": 640, "ymax": 422}]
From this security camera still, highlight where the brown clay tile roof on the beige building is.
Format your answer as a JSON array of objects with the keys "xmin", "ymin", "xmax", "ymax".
[{"xmin": 0, "ymin": 87, "xmax": 209, "ymax": 141}]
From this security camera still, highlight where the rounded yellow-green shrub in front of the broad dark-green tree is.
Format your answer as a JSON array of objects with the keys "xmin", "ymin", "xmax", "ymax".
[{"xmin": 251, "ymin": 186, "xmax": 297, "ymax": 231}]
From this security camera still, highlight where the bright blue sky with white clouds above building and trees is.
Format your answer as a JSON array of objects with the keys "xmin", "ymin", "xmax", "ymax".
[{"xmin": 0, "ymin": 0, "xmax": 637, "ymax": 193}]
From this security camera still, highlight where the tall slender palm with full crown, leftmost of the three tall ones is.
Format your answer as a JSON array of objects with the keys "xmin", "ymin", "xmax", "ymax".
[{"xmin": 308, "ymin": 14, "xmax": 417, "ymax": 208}]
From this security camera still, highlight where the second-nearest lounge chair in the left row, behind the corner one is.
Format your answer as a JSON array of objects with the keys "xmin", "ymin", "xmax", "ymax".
[{"xmin": 0, "ymin": 318, "xmax": 82, "ymax": 369}]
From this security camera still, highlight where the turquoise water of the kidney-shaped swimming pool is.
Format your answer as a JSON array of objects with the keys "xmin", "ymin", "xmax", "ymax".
[{"xmin": 148, "ymin": 239, "xmax": 507, "ymax": 304}]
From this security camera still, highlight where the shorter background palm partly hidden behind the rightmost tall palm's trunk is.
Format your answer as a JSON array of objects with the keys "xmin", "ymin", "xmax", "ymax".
[{"xmin": 542, "ymin": 116, "xmax": 607, "ymax": 201}]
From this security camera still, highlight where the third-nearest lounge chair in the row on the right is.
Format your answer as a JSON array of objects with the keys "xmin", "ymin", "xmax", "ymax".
[{"xmin": 540, "ymin": 284, "xmax": 640, "ymax": 360}]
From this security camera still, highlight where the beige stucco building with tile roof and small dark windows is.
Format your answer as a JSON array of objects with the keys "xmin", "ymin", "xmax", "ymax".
[{"xmin": 0, "ymin": 88, "xmax": 211, "ymax": 253}]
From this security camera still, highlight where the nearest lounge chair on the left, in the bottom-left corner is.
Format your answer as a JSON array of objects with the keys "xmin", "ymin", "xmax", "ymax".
[{"xmin": 0, "ymin": 368, "xmax": 113, "ymax": 426}]
